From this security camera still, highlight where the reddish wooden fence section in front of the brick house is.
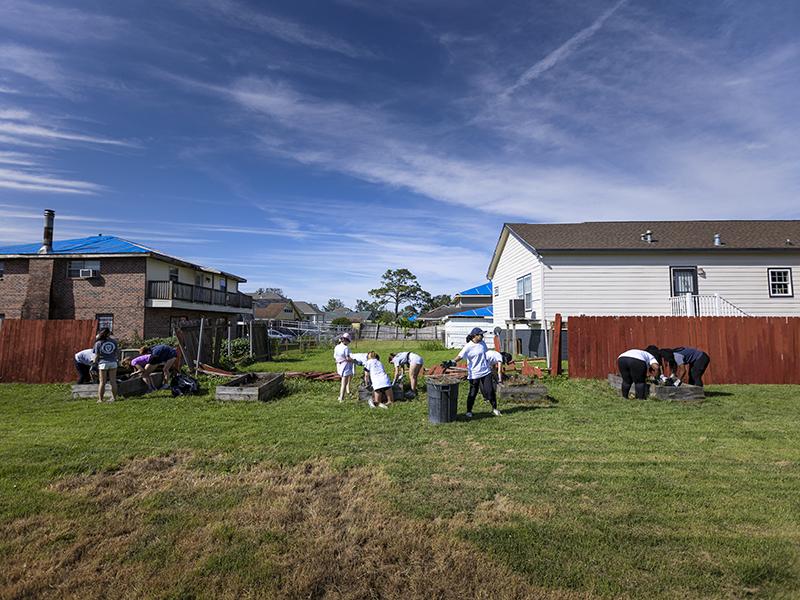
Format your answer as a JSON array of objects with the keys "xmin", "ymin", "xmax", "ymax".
[{"xmin": 0, "ymin": 319, "xmax": 97, "ymax": 383}]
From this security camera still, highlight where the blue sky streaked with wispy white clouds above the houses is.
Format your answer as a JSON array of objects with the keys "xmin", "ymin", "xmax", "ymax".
[{"xmin": 0, "ymin": 0, "xmax": 800, "ymax": 303}]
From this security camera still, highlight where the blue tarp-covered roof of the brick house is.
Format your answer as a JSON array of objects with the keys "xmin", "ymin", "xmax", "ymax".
[{"xmin": 0, "ymin": 235, "xmax": 247, "ymax": 282}]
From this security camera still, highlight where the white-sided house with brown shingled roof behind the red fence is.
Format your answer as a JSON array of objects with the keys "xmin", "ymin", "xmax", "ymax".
[{"xmin": 488, "ymin": 221, "xmax": 800, "ymax": 356}]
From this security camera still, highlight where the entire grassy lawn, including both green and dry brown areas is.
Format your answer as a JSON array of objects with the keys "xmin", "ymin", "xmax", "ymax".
[{"xmin": 0, "ymin": 342, "xmax": 800, "ymax": 598}]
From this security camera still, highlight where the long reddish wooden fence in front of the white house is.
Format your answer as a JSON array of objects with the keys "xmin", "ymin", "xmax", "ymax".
[{"xmin": 567, "ymin": 317, "xmax": 800, "ymax": 383}]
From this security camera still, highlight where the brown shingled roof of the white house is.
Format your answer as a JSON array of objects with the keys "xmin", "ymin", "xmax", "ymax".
[{"xmin": 507, "ymin": 221, "xmax": 800, "ymax": 252}]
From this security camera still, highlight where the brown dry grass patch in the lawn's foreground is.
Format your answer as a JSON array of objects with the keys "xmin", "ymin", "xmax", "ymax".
[{"xmin": 0, "ymin": 454, "xmax": 588, "ymax": 599}]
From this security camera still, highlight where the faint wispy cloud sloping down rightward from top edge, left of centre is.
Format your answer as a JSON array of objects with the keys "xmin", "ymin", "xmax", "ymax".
[{"xmin": 184, "ymin": 0, "xmax": 374, "ymax": 58}]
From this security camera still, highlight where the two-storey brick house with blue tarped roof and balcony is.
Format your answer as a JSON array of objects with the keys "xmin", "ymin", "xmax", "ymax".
[{"xmin": 0, "ymin": 214, "xmax": 253, "ymax": 340}]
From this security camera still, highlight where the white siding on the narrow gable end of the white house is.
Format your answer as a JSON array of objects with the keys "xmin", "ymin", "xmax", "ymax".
[{"xmin": 492, "ymin": 234, "xmax": 542, "ymax": 329}]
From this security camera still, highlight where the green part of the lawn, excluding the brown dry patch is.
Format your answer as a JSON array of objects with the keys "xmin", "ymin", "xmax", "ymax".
[{"xmin": 0, "ymin": 341, "xmax": 800, "ymax": 598}]
